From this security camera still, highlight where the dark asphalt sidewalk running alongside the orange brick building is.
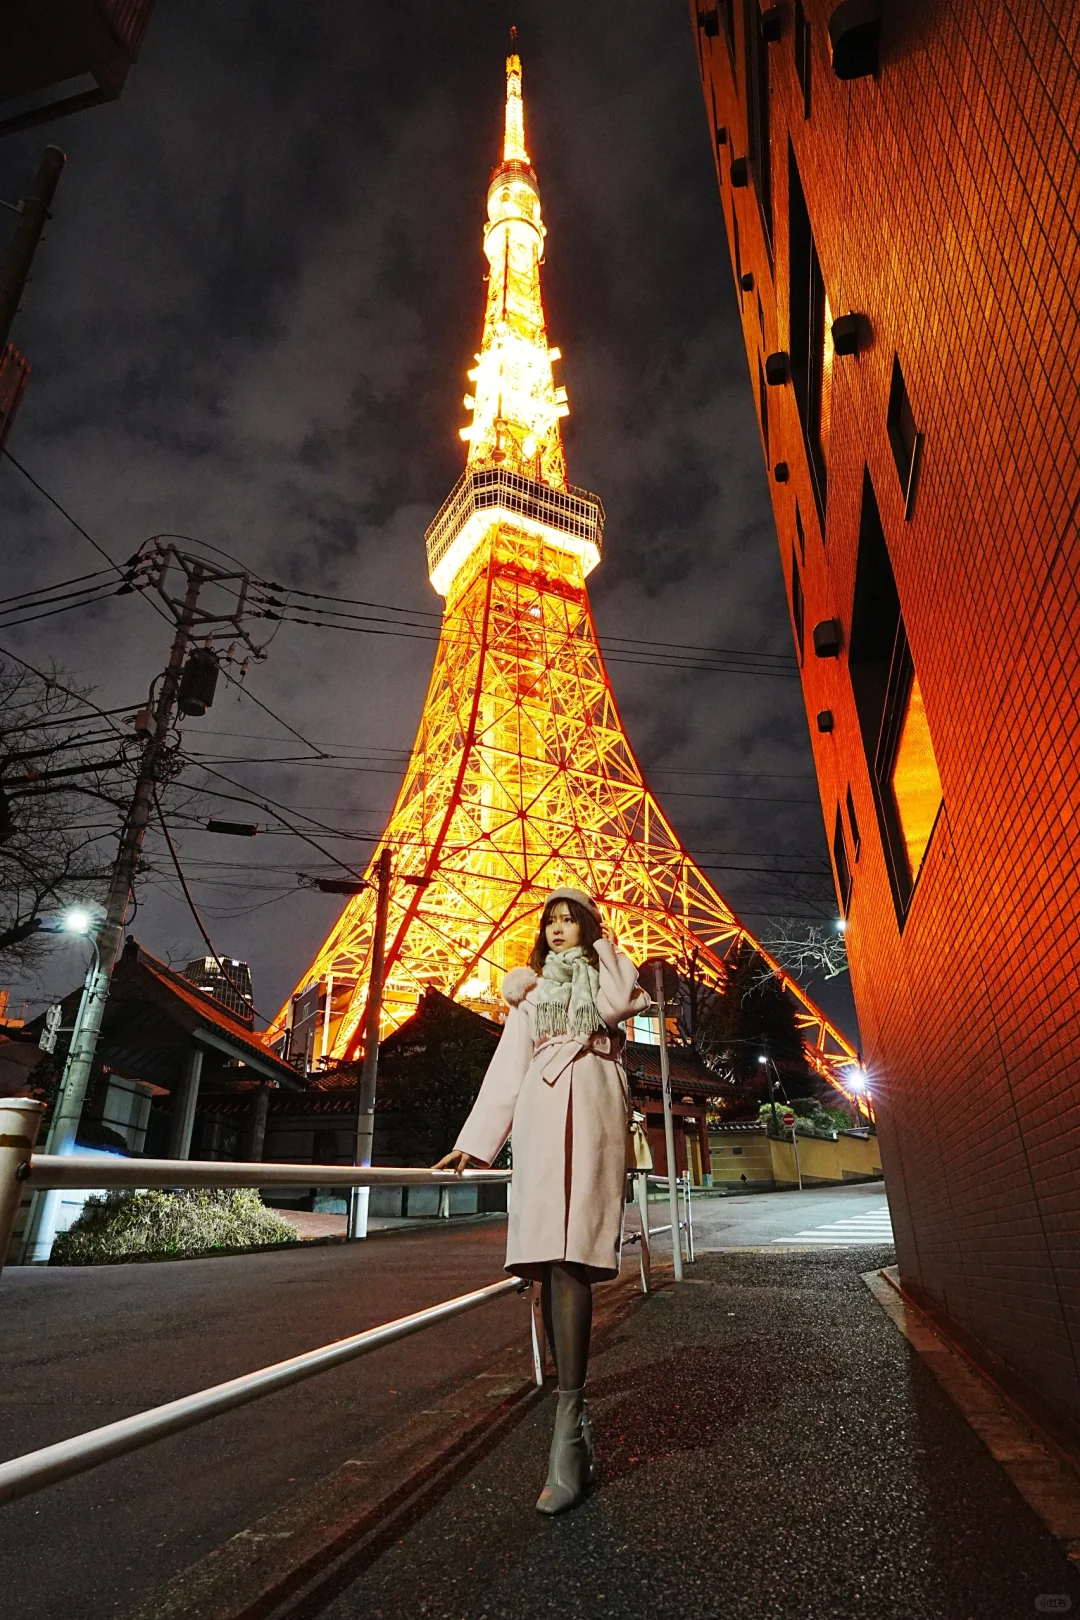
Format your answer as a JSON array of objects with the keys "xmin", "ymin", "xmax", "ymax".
[{"xmin": 304, "ymin": 1247, "xmax": 1080, "ymax": 1620}]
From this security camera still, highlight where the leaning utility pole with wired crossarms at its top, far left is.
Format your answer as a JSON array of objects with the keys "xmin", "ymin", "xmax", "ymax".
[{"xmin": 23, "ymin": 544, "xmax": 268, "ymax": 1264}]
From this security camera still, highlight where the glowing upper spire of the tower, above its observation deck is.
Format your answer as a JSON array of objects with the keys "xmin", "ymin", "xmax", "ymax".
[{"xmin": 461, "ymin": 39, "xmax": 570, "ymax": 489}]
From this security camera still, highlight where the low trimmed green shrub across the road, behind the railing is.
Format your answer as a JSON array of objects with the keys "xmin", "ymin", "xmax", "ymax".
[{"xmin": 50, "ymin": 1187, "xmax": 296, "ymax": 1265}]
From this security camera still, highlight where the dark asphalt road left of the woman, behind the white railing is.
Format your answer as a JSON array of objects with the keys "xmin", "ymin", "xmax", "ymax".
[{"xmin": 0, "ymin": 1220, "xmax": 528, "ymax": 1620}]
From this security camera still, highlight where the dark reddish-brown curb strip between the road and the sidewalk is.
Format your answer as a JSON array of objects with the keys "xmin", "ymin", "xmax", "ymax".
[{"xmin": 125, "ymin": 1265, "xmax": 654, "ymax": 1620}]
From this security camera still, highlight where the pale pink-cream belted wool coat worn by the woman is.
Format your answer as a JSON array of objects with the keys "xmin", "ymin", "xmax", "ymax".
[{"xmin": 455, "ymin": 940, "xmax": 649, "ymax": 1281}]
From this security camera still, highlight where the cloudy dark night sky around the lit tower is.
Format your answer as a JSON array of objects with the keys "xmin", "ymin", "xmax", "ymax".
[{"xmin": 0, "ymin": 0, "xmax": 855, "ymax": 1034}]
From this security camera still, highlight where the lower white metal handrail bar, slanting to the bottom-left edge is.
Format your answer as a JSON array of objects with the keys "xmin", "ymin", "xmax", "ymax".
[{"xmin": 0, "ymin": 1277, "xmax": 524, "ymax": 1502}]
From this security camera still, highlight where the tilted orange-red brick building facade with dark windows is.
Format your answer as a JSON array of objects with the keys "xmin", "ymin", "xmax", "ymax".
[{"xmin": 691, "ymin": 0, "xmax": 1080, "ymax": 1422}]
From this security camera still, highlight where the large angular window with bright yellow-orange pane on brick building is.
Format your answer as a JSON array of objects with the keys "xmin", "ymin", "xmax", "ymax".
[{"xmin": 848, "ymin": 473, "xmax": 941, "ymax": 919}]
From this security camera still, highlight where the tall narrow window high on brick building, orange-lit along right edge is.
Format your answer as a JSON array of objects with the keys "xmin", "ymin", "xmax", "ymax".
[{"xmin": 787, "ymin": 146, "xmax": 832, "ymax": 531}]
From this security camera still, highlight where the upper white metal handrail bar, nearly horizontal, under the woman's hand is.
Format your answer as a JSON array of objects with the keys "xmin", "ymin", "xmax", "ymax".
[{"xmin": 19, "ymin": 1153, "xmax": 512, "ymax": 1192}]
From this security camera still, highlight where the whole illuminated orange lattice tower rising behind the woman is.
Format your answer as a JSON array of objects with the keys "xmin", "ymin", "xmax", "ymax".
[{"xmin": 267, "ymin": 55, "xmax": 855, "ymax": 1081}]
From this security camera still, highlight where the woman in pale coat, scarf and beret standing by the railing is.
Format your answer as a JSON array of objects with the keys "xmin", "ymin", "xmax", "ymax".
[{"xmin": 436, "ymin": 889, "xmax": 649, "ymax": 1513}]
